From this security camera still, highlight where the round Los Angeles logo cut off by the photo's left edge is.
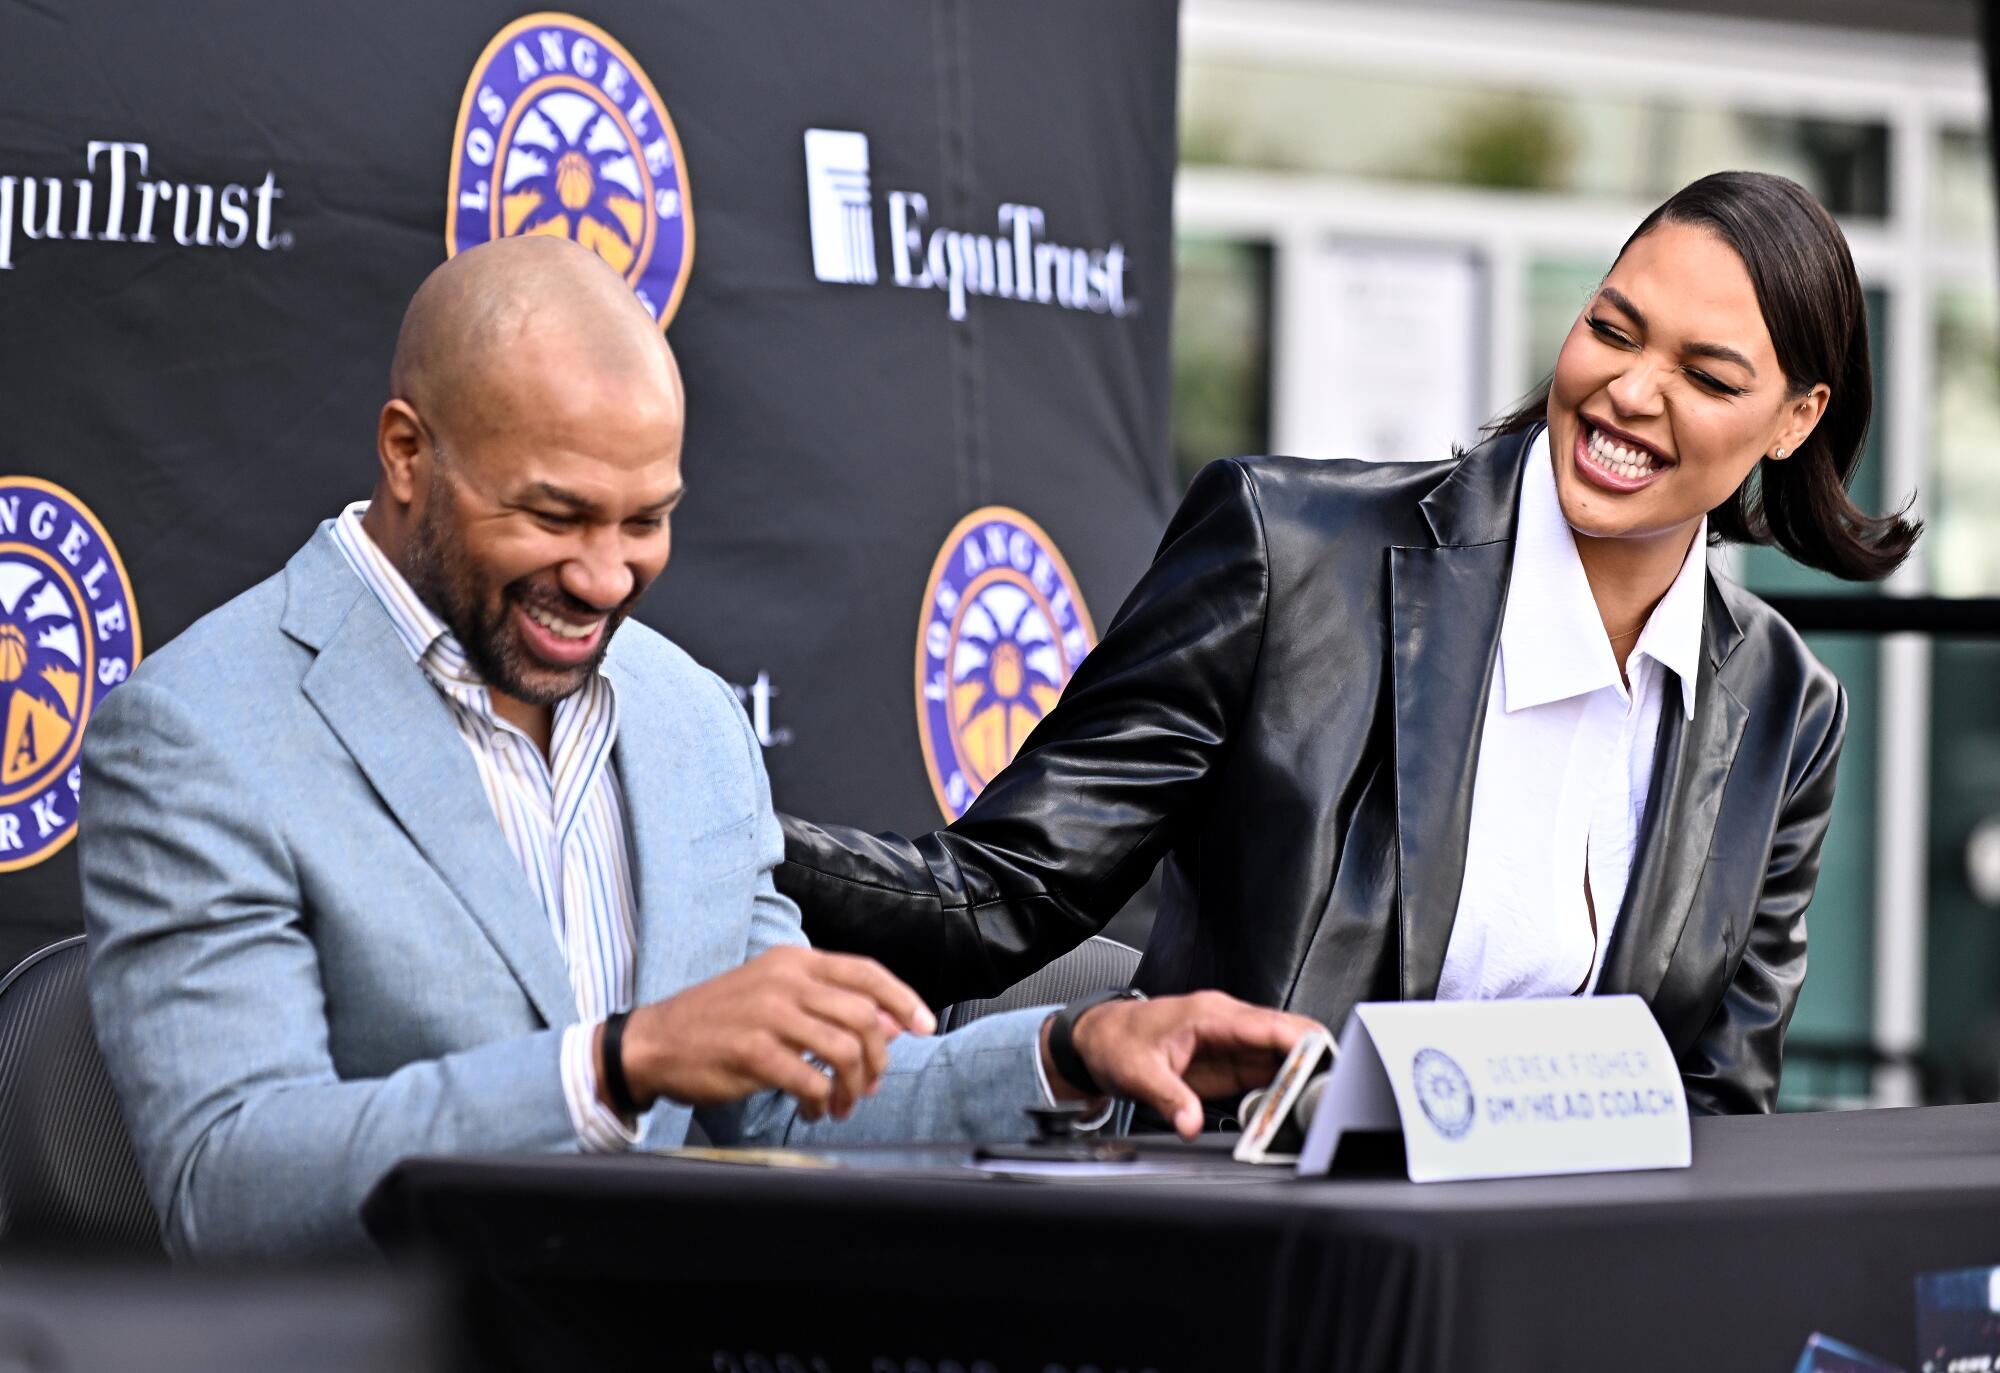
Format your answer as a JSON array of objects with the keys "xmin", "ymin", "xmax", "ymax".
[{"xmin": 0, "ymin": 476, "xmax": 138, "ymax": 873}]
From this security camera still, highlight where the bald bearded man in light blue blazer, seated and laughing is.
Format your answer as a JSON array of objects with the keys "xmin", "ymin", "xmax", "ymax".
[{"xmin": 80, "ymin": 238, "xmax": 1306, "ymax": 1257}]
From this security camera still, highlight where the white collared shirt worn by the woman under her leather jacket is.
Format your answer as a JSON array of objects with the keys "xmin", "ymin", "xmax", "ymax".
[{"xmin": 1438, "ymin": 430, "xmax": 1708, "ymax": 1001}]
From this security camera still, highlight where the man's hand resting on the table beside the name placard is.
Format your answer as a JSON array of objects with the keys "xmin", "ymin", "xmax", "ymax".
[{"xmin": 1042, "ymin": 991, "xmax": 1320, "ymax": 1139}]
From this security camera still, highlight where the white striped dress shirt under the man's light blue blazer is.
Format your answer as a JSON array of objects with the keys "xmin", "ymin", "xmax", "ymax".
[{"xmin": 332, "ymin": 500, "xmax": 638, "ymax": 1153}]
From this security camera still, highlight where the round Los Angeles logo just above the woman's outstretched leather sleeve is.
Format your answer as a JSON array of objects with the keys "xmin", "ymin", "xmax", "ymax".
[{"xmin": 916, "ymin": 506, "xmax": 1098, "ymax": 821}]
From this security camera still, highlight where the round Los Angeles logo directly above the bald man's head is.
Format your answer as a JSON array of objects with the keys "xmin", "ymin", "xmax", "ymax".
[{"xmin": 444, "ymin": 14, "xmax": 694, "ymax": 328}]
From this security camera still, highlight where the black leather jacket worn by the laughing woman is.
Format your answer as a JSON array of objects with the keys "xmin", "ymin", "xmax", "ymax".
[{"xmin": 778, "ymin": 432, "xmax": 1846, "ymax": 1111}]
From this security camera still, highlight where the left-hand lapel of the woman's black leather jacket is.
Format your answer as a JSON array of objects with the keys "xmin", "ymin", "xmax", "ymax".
[{"xmin": 1390, "ymin": 430, "xmax": 1534, "ymax": 1001}]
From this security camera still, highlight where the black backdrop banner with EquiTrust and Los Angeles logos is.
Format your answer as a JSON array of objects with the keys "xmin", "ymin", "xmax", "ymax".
[{"xmin": 0, "ymin": 0, "xmax": 1176, "ymax": 969}]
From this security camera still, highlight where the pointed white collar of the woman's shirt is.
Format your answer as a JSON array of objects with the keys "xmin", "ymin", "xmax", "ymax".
[{"xmin": 1500, "ymin": 428, "xmax": 1708, "ymax": 719}]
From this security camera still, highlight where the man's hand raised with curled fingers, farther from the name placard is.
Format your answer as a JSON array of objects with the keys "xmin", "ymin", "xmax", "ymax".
[{"xmin": 608, "ymin": 949, "xmax": 938, "ymax": 1121}]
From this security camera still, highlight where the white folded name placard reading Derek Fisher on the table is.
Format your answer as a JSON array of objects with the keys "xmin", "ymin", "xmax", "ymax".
[{"xmin": 1298, "ymin": 997, "xmax": 1692, "ymax": 1183}]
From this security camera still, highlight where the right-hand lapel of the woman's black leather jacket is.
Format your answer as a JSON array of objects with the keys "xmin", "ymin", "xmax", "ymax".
[{"xmin": 1598, "ymin": 576, "xmax": 1750, "ymax": 1001}]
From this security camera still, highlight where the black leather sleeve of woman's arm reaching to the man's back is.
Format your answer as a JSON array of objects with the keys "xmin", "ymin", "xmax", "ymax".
[{"xmin": 778, "ymin": 462, "xmax": 1270, "ymax": 1005}]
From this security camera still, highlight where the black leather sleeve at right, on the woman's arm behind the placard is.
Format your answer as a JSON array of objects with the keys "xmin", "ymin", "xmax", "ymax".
[{"xmin": 1680, "ymin": 676, "xmax": 1848, "ymax": 1115}]
